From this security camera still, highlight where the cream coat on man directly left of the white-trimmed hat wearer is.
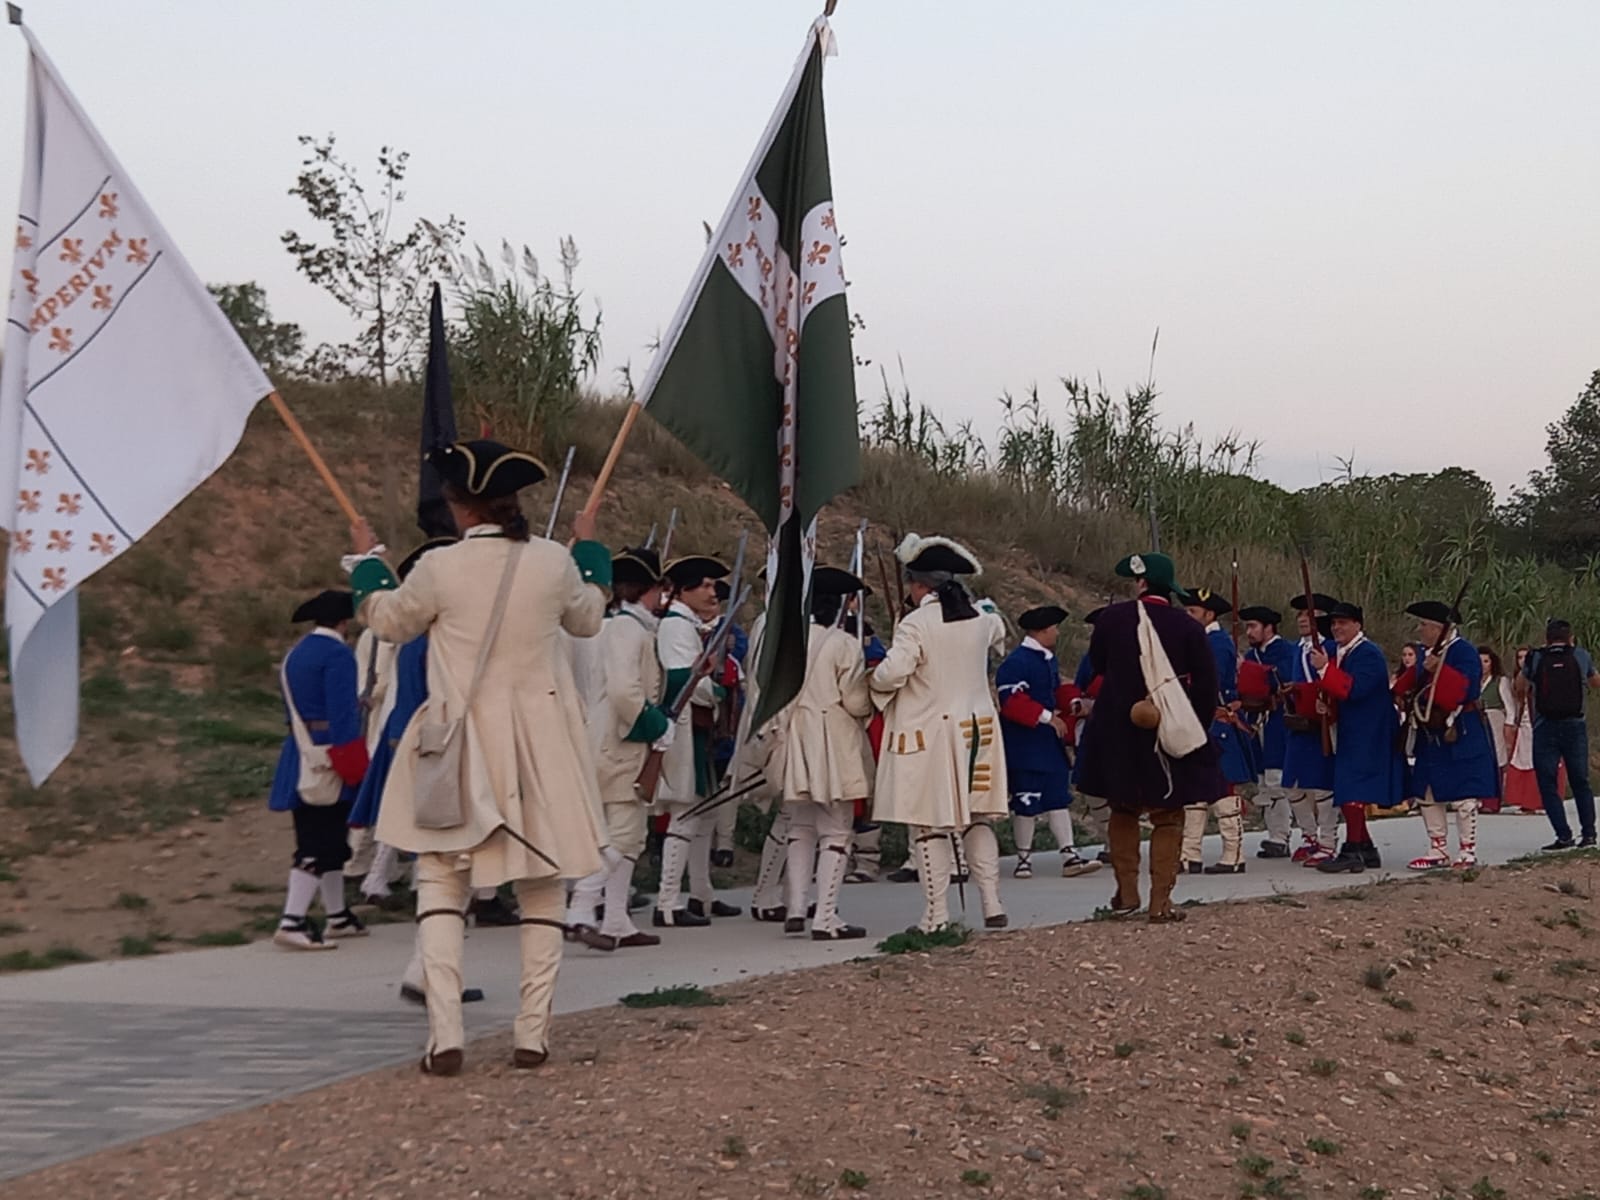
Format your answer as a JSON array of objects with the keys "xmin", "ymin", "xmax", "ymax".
[{"xmin": 782, "ymin": 624, "xmax": 872, "ymax": 805}]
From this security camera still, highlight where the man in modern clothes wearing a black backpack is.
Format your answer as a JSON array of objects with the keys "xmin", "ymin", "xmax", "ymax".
[{"xmin": 1517, "ymin": 618, "xmax": 1600, "ymax": 850}]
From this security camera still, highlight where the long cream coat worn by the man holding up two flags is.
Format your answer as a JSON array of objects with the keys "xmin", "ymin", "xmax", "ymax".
[{"xmin": 360, "ymin": 526, "xmax": 606, "ymax": 886}]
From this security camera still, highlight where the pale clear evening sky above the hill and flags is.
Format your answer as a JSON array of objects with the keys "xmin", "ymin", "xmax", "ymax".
[{"xmin": 0, "ymin": 0, "xmax": 1600, "ymax": 490}]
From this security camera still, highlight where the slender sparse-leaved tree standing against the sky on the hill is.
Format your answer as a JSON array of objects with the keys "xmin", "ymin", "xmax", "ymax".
[{"xmin": 283, "ymin": 133, "xmax": 462, "ymax": 384}]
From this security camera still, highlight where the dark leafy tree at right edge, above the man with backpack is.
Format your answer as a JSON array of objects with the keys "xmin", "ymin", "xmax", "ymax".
[{"xmin": 1502, "ymin": 371, "xmax": 1600, "ymax": 565}]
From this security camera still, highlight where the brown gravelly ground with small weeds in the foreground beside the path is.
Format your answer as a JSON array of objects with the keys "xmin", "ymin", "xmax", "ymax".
[{"xmin": 18, "ymin": 859, "xmax": 1600, "ymax": 1200}]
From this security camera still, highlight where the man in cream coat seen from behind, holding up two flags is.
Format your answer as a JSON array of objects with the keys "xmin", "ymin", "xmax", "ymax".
[{"xmin": 350, "ymin": 440, "xmax": 611, "ymax": 1075}]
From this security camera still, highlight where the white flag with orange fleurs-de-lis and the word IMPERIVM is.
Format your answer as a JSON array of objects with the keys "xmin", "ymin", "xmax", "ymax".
[{"xmin": 0, "ymin": 21, "xmax": 272, "ymax": 786}]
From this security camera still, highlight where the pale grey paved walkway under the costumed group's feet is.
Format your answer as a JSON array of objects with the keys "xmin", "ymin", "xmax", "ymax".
[{"xmin": 0, "ymin": 816, "xmax": 1574, "ymax": 1179}]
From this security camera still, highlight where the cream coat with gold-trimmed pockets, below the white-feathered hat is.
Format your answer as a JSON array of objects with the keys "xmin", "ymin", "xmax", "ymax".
[{"xmin": 870, "ymin": 595, "xmax": 1006, "ymax": 829}]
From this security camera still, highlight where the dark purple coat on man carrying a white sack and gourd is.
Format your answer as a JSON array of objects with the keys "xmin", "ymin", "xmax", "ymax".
[{"xmin": 1078, "ymin": 600, "xmax": 1227, "ymax": 811}]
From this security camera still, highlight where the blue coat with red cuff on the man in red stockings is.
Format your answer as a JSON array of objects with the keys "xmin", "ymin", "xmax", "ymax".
[{"xmin": 1322, "ymin": 638, "xmax": 1403, "ymax": 808}]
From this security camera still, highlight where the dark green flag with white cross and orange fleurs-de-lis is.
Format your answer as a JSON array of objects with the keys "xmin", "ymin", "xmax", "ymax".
[{"xmin": 638, "ymin": 18, "xmax": 861, "ymax": 728}]
